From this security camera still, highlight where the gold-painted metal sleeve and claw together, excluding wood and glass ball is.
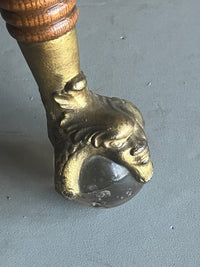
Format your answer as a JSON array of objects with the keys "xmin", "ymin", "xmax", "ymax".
[{"xmin": 19, "ymin": 28, "xmax": 153, "ymax": 203}]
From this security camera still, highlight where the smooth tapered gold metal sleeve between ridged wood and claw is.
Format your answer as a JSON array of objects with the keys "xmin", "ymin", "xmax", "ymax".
[{"xmin": 18, "ymin": 27, "xmax": 80, "ymax": 117}]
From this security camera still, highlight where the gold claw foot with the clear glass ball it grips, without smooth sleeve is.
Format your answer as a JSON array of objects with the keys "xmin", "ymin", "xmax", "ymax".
[{"xmin": 49, "ymin": 73, "xmax": 152, "ymax": 208}]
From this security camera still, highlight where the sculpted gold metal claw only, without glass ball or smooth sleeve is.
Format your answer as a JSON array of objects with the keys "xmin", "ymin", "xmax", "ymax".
[{"xmin": 52, "ymin": 72, "xmax": 153, "ymax": 198}]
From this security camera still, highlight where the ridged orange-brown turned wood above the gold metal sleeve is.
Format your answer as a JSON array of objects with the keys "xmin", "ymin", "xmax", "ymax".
[{"xmin": 0, "ymin": 0, "xmax": 78, "ymax": 43}]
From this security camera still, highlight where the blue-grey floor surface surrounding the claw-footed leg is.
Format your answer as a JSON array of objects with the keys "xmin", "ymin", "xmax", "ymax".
[{"xmin": 0, "ymin": 0, "xmax": 200, "ymax": 267}]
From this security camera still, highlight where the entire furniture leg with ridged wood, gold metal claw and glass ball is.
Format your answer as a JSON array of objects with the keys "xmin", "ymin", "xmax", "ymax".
[{"xmin": 0, "ymin": 0, "xmax": 153, "ymax": 208}]
